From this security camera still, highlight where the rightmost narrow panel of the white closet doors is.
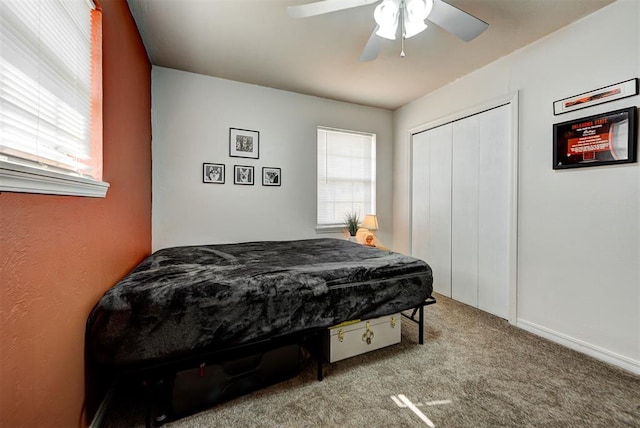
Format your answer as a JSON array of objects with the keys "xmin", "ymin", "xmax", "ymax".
[{"xmin": 478, "ymin": 105, "xmax": 511, "ymax": 318}]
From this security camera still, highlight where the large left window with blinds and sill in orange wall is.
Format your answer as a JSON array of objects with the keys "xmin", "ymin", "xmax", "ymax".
[{"xmin": 0, "ymin": 0, "xmax": 108, "ymax": 196}]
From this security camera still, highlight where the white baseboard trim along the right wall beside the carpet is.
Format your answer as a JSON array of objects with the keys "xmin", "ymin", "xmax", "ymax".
[{"xmin": 516, "ymin": 318, "xmax": 640, "ymax": 375}]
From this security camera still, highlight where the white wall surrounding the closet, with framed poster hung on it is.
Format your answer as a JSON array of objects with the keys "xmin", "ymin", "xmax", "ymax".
[{"xmin": 393, "ymin": 0, "xmax": 640, "ymax": 373}]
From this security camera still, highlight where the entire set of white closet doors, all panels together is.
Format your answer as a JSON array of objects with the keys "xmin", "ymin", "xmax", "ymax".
[{"xmin": 411, "ymin": 104, "xmax": 516, "ymax": 318}]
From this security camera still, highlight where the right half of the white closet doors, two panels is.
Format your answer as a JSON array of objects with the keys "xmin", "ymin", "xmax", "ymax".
[{"xmin": 451, "ymin": 105, "xmax": 511, "ymax": 318}]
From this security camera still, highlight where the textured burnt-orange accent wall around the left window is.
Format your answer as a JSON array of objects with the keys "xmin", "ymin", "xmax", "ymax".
[{"xmin": 0, "ymin": 0, "xmax": 151, "ymax": 427}]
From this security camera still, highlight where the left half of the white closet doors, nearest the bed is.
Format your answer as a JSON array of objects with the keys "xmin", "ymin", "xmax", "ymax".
[{"xmin": 411, "ymin": 124, "xmax": 452, "ymax": 297}]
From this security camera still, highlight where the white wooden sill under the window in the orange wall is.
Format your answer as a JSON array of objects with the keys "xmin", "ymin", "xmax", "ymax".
[{"xmin": 0, "ymin": 161, "xmax": 109, "ymax": 198}]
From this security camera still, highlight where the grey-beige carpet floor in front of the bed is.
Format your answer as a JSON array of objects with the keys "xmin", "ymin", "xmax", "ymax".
[{"xmin": 103, "ymin": 296, "xmax": 640, "ymax": 428}]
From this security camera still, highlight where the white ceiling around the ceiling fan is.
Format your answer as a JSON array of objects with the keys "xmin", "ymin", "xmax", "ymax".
[{"xmin": 128, "ymin": 0, "xmax": 614, "ymax": 110}]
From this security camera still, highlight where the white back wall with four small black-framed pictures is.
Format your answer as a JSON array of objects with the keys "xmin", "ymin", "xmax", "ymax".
[{"xmin": 152, "ymin": 67, "xmax": 393, "ymax": 251}]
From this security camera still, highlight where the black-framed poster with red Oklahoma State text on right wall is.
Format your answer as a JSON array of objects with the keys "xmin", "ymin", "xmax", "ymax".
[{"xmin": 553, "ymin": 107, "xmax": 638, "ymax": 169}]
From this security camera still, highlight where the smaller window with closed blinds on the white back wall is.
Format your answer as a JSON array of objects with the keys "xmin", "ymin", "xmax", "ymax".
[{"xmin": 317, "ymin": 127, "xmax": 376, "ymax": 230}]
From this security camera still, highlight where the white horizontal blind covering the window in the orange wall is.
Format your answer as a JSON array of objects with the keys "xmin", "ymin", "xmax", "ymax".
[{"xmin": 0, "ymin": 0, "xmax": 101, "ymax": 179}]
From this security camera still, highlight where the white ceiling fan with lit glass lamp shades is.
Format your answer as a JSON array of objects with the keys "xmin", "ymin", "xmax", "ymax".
[{"xmin": 287, "ymin": 0, "xmax": 489, "ymax": 61}]
